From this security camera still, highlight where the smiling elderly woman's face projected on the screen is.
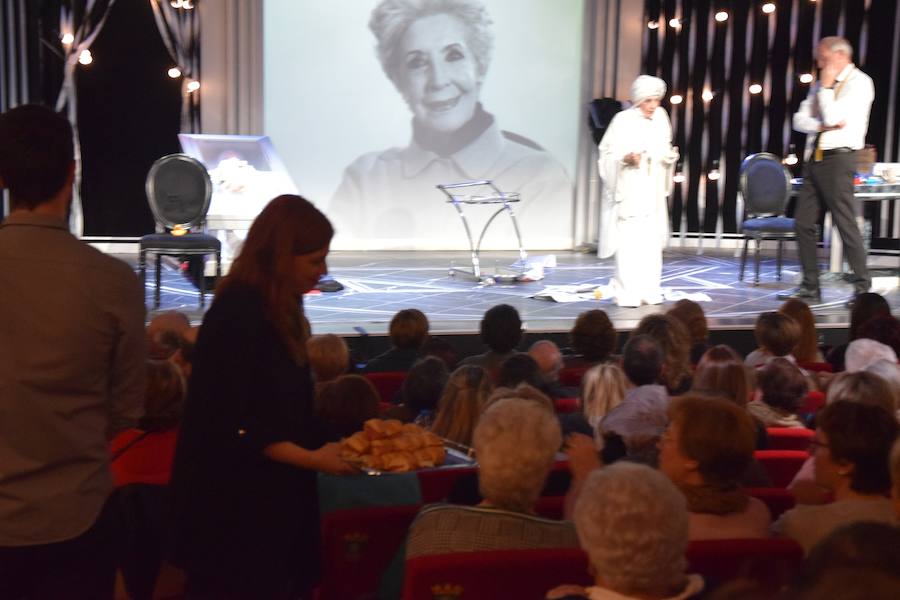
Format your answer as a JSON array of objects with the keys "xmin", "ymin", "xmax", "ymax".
[{"xmin": 399, "ymin": 14, "xmax": 481, "ymax": 132}]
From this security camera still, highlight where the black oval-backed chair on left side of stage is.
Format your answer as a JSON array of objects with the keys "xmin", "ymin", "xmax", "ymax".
[{"xmin": 138, "ymin": 154, "xmax": 222, "ymax": 308}]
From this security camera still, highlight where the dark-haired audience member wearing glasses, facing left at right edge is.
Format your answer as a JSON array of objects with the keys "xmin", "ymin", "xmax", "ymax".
[{"xmin": 773, "ymin": 400, "xmax": 898, "ymax": 553}]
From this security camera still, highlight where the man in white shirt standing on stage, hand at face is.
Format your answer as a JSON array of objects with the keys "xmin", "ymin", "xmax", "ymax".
[{"xmin": 778, "ymin": 37, "xmax": 875, "ymax": 306}]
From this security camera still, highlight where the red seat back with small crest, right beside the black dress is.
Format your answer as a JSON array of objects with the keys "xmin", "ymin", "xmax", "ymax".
[{"xmin": 319, "ymin": 505, "xmax": 419, "ymax": 600}]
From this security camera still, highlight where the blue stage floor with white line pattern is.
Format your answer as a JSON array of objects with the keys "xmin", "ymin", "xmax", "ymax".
[{"xmin": 147, "ymin": 248, "xmax": 900, "ymax": 335}]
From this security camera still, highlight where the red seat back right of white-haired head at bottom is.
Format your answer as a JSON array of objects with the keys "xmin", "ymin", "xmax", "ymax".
[{"xmin": 687, "ymin": 538, "xmax": 803, "ymax": 592}]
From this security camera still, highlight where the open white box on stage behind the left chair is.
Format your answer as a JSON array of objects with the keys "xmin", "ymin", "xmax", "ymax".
[{"xmin": 178, "ymin": 133, "xmax": 297, "ymax": 275}]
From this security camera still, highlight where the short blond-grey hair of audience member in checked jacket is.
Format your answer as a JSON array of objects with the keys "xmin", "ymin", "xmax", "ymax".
[{"xmin": 473, "ymin": 398, "xmax": 562, "ymax": 512}]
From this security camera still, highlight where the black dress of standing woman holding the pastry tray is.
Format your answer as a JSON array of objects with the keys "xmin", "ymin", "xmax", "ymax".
[{"xmin": 171, "ymin": 287, "xmax": 320, "ymax": 598}]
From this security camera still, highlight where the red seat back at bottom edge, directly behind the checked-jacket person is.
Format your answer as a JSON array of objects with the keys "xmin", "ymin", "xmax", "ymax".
[{"xmin": 403, "ymin": 548, "xmax": 593, "ymax": 600}]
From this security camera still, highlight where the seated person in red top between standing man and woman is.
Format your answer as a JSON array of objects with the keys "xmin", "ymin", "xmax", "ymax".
[{"xmin": 110, "ymin": 359, "xmax": 187, "ymax": 487}]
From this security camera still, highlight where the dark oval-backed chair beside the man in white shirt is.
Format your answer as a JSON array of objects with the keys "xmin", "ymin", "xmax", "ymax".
[{"xmin": 738, "ymin": 152, "xmax": 795, "ymax": 285}]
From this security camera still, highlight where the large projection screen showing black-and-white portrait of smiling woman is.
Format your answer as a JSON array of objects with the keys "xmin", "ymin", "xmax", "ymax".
[{"xmin": 263, "ymin": 0, "xmax": 585, "ymax": 250}]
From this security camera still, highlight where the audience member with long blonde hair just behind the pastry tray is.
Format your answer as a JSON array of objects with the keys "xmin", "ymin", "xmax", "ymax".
[{"xmin": 431, "ymin": 365, "xmax": 494, "ymax": 446}]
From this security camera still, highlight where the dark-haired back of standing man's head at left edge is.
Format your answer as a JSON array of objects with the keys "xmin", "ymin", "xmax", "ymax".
[{"xmin": 0, "ymin": 104, "xmax": 74, "ymax": 210}]
